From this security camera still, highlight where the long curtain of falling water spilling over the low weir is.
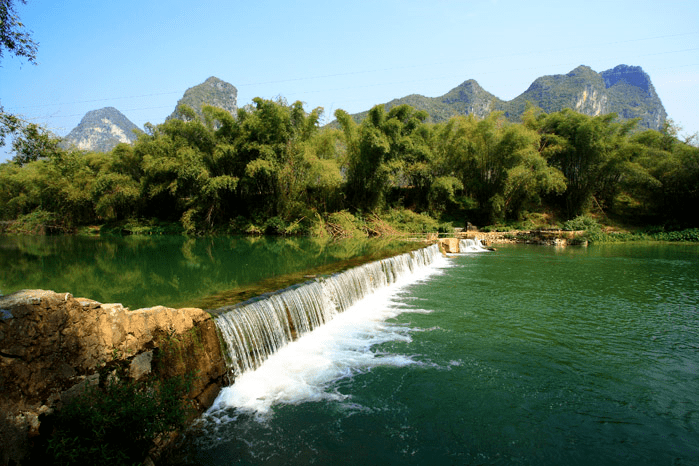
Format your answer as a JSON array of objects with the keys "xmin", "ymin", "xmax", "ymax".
[{"xmin": 213, "ymin": 244, "xmax": 440, "ymax": 377}]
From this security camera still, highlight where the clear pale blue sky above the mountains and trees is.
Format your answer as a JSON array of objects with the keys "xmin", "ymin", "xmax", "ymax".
[{"xmin": 0, "ymin": 0, "xmax": 699, "ymax": 160}]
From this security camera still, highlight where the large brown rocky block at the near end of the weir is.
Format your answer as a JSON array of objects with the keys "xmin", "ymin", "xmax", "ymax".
[{"xmin": 0, "ymin": 290, "xmax": 226, "ymax": 465}]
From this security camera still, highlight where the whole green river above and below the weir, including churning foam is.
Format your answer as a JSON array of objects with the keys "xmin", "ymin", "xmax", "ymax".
[{"xmin": 0, "ymin": 238, "xmax": 699, "ymax": 465}]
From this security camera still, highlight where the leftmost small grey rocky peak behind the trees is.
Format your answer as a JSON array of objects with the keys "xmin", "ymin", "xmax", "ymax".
[{"xmin": 61, "ymin": 107, "xmax": 140, "ymax": 152}]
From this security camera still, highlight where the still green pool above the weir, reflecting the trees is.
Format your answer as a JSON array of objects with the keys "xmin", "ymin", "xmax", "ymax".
[{"xmin": 0, "ymin": 236, "xmax": 416, "ymax": 309}]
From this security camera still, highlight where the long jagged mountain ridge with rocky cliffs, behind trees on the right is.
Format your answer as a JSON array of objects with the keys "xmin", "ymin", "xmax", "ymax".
[{"xmin": 353, "ymin": 65, "xmax": 667, "ymax": 130}]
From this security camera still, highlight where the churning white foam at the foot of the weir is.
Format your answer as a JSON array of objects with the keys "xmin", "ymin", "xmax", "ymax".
[{"xmin": 209, "ymin": 256, "xmax": 449, "ymax": 416}]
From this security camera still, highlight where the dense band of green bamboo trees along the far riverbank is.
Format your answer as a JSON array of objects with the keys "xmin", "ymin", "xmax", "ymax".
[{"xmin": 0, "ymin": 98, "xmax": 699, "ymax": 240}]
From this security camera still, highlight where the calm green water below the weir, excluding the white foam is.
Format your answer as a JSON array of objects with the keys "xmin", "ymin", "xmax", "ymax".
[{"xmin": 173, "ymin": 244, "xmax": 699, "ymax": 465}]
